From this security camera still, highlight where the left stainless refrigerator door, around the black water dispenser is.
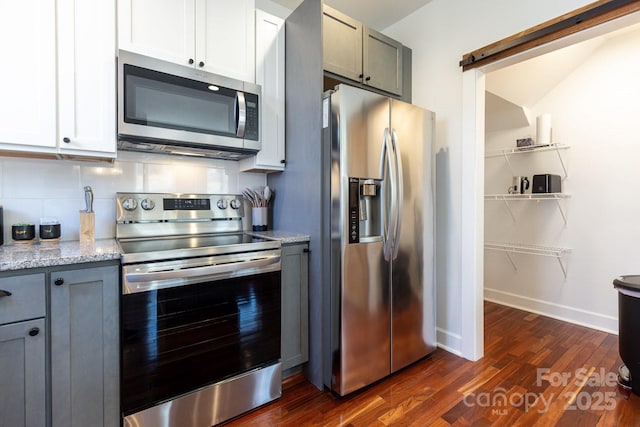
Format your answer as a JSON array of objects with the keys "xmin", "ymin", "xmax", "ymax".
[{"xmin": 325, "ymin": 86, "xmax": 391, "ymax": 396}]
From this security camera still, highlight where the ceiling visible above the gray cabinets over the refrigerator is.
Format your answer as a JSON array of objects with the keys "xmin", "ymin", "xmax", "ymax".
[{"xmin": 273, "ymin": 0, "xmax": 431, "ymax": 31}]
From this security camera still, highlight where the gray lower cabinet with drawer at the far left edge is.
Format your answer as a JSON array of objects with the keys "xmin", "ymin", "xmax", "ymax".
[{"xmin": 0, "ymin": 274, "xmax": 47, "ymax": 427}]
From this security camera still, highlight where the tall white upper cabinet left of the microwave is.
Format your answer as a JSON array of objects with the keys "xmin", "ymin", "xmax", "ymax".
[{"xmin": 0, "ymin": 0, "xmax": 116, "ymax": 158}]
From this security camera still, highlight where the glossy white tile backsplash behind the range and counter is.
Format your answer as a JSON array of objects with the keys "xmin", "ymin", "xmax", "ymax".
[{"xmin": 0, "ymin": 152, "xmax": 266, "ymax": 244}]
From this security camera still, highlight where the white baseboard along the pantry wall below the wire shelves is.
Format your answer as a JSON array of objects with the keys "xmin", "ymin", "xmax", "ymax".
[{"xmin": 484, "ymin": 288, "xmax": 618, "ymax": 335}]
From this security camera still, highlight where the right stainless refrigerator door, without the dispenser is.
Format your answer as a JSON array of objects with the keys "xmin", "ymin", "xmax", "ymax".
[{"xmin": 391, "ymin": 100, "xmax": 436, "ymax": 372}]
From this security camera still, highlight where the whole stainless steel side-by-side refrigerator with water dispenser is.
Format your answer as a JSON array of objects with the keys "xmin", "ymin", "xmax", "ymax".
[{"xmin": 322, "ymin": 85, "xmax": 436, "ymax": 396}]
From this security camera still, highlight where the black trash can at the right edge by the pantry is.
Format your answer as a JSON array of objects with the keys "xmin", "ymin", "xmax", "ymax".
[{"xmin": 613, "ymin": 275, "xmax": 640, "ymax": 395}]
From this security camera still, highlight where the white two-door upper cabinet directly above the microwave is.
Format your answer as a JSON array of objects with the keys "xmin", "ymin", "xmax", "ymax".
[{"xmin": 118, "ymin": 0, "xmax": 255, "ymax": 82}]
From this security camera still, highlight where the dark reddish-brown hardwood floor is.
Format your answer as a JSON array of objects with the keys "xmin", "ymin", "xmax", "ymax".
[{"xmin": 227, "ymin": 303, "xmax": 640, "ymax": 426}]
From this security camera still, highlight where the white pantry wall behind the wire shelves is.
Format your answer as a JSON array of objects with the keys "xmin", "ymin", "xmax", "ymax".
[{"xmin": 485, "ymin": 26, "xmax": 640, "ymax": 333}]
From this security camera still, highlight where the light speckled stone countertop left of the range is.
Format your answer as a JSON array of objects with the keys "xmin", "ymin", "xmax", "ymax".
[{"xmin": 0, "ymin": 239, "xmax": 120, "ymax": 271}]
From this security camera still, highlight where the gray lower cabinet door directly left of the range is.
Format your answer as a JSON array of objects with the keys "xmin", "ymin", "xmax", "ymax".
[{"xmin": 50, "ymin": 266, "xmax": 120, "ymax": 427}]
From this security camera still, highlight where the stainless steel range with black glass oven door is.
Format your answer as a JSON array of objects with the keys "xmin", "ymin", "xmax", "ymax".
[{"xmin": 116, "ymin": 193, "xmax": 281, "ymax": 427}]
